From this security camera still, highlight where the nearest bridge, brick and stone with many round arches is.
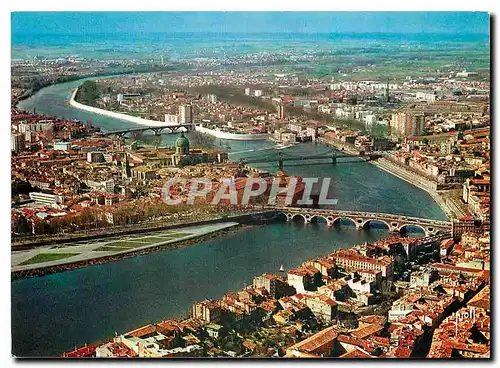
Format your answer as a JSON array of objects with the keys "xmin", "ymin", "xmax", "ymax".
[{"xmin": 270, "ymin": 207, "xmax": 451, "ymax": 236}]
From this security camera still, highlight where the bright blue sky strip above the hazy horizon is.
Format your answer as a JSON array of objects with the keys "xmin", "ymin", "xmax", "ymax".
[{"xmin": 12, "ymin": 12, "xmax": 489, "ymax": 34}]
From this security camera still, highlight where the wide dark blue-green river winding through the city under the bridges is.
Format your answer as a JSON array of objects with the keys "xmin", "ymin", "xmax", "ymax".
[{"xmin": 12, "ymin": 77, "xmax": 446, "ymax": 357}]
